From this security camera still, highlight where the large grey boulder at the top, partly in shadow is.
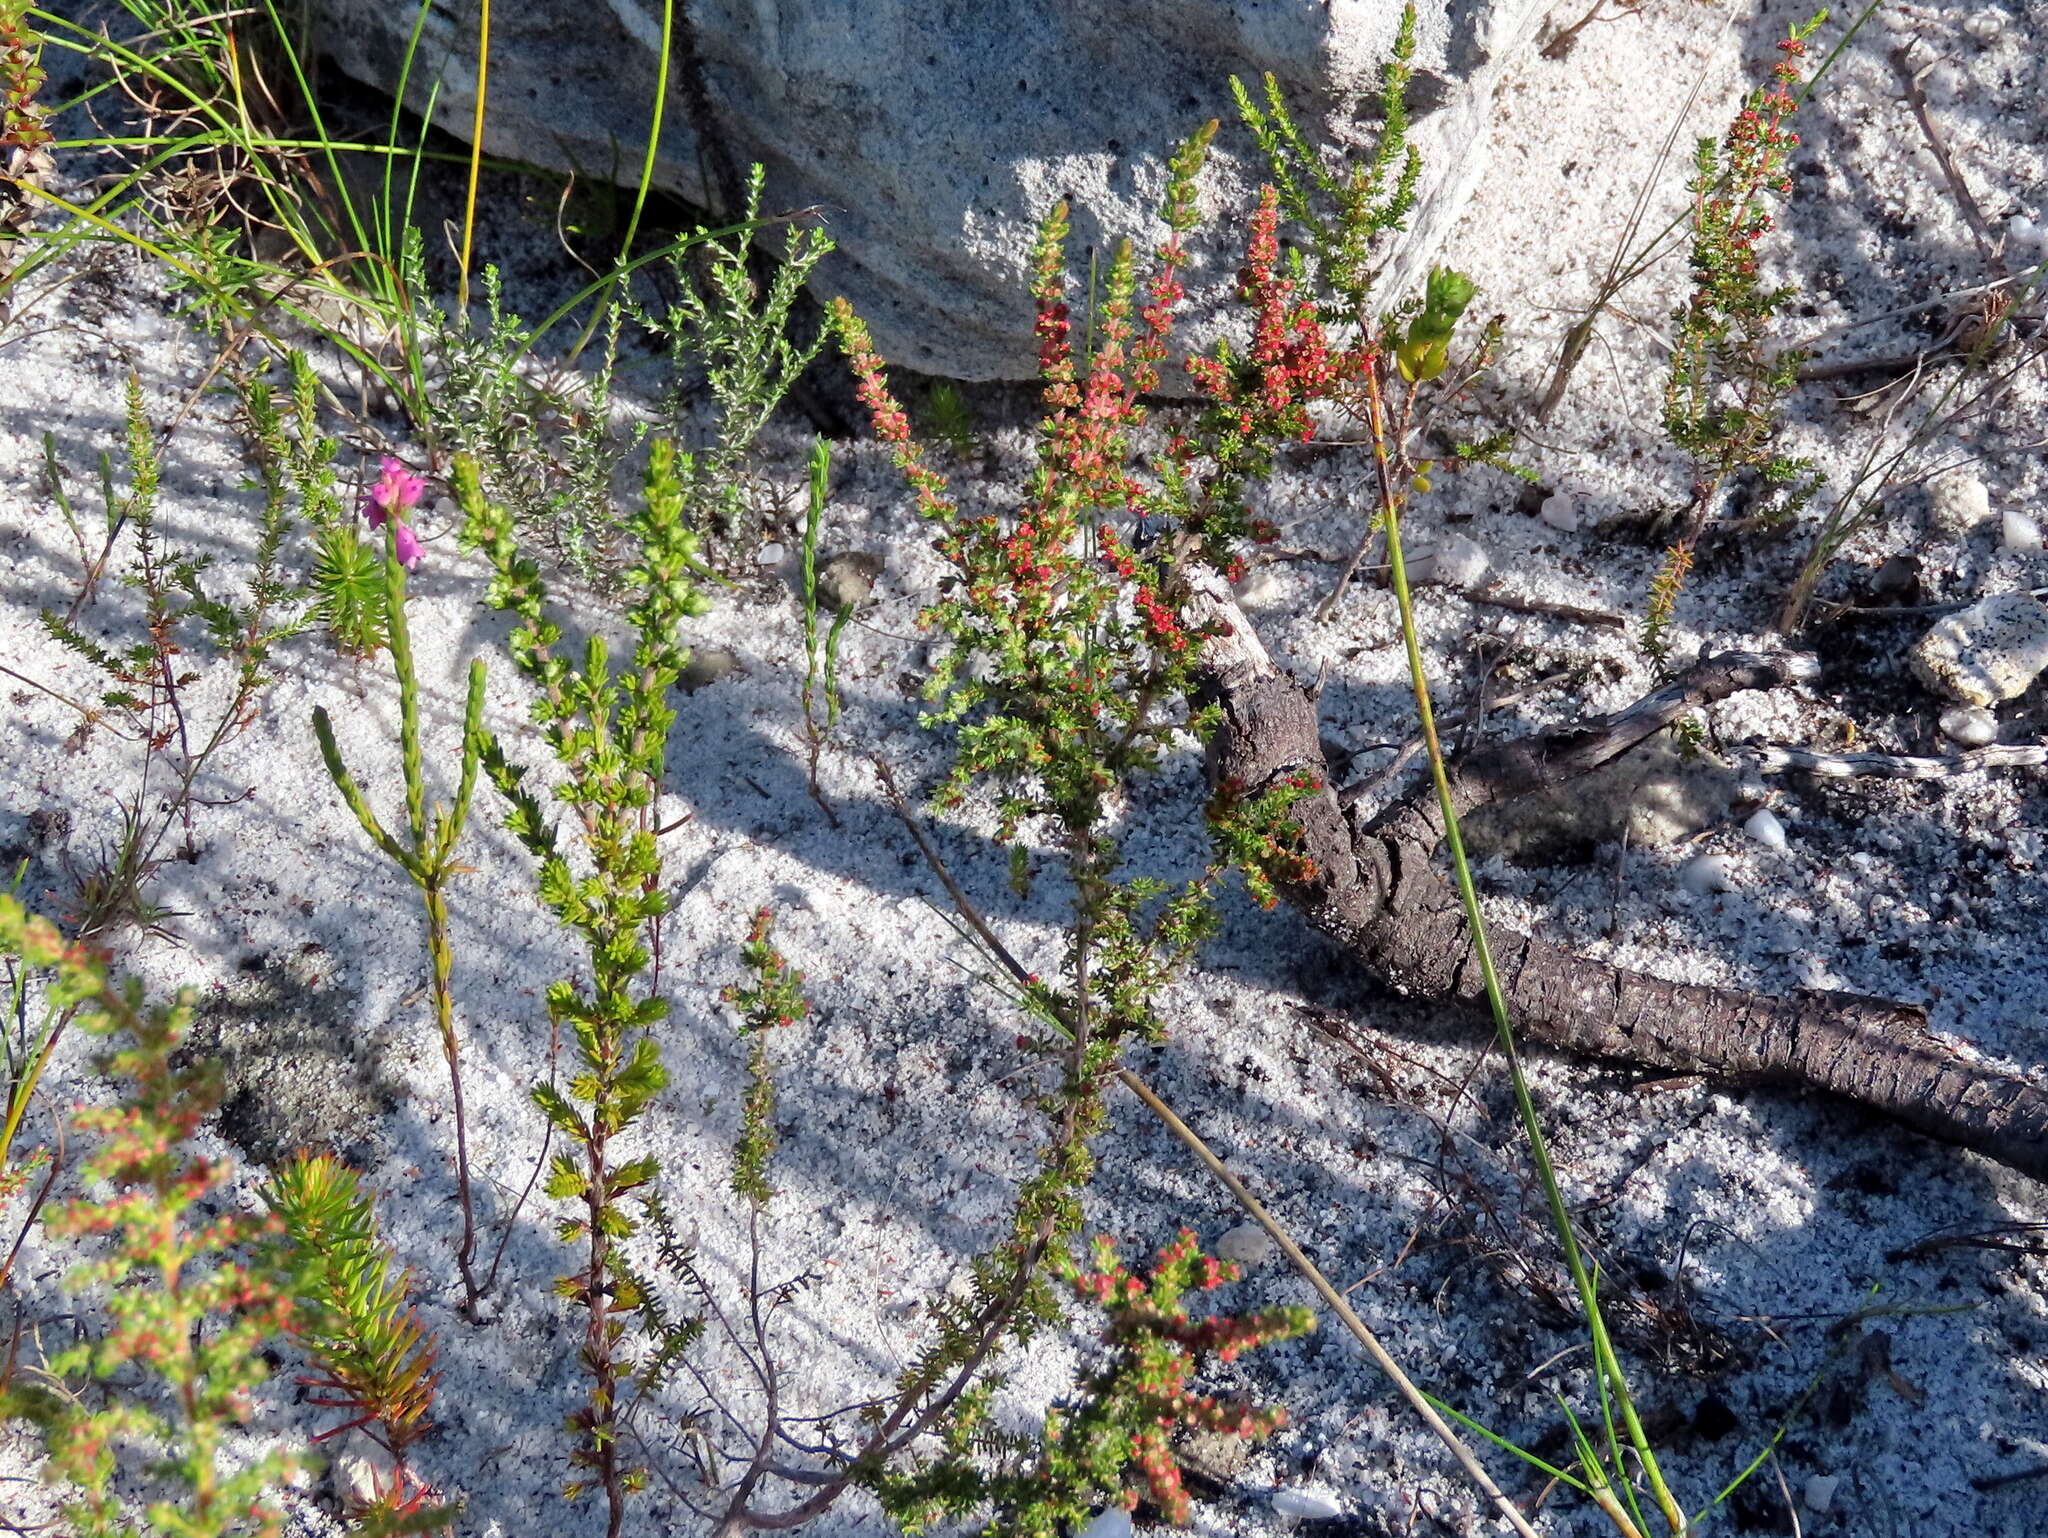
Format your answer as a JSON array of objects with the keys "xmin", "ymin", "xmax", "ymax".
[{"xmin": 317, "ymin": 0, "xmax": 1548, "ymax": 389}]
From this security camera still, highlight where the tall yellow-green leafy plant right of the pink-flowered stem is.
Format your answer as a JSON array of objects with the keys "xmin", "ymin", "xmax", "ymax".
[{"xmin": 455, "ymin": 440, "xmax": 709, "ymax": 1524}]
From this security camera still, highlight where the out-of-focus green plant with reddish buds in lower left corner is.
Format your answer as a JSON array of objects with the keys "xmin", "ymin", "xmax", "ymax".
[{"xmin": 0, "ymin": 895, "xmax": 293, "ymax": 1538}]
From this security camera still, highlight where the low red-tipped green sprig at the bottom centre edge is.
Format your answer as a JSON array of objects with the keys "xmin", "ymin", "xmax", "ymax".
[{"xmin": 879, "ymin": 1229, "xmax": 1315, "ymax": 1538}]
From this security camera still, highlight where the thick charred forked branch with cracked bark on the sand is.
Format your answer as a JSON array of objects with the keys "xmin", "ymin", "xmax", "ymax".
[{"xmin": 1188, "ymin": 584, "xmax": 2048, "ymax": 1180}]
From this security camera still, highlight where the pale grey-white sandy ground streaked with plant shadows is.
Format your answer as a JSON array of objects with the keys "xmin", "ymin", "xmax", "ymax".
[{"xmin": 0, "ymin": 0, "xmax": 2048, "ymax": 1538}]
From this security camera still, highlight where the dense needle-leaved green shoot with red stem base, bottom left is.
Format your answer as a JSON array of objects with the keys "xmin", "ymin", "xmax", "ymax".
[{"xmin": 264, "ymin": 1153, "xmax": 453, "ymax": 1530}]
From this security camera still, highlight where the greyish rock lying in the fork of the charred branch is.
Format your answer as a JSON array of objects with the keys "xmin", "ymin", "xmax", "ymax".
[{"xmin": 1466, "ymin": 735, "xmax": 1743, "ymax": 864}]
